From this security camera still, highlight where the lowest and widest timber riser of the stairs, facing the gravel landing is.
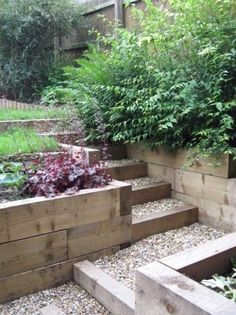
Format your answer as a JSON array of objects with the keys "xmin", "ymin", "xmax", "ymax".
[{"xmin": 132, "ymin": 205, "xmax": 198, "ymax": 241}]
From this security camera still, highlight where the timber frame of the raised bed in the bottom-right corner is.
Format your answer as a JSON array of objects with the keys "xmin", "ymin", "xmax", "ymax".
[{"xmin": 135, "ymin": 233, "xmax": 236, "ymax": 315}]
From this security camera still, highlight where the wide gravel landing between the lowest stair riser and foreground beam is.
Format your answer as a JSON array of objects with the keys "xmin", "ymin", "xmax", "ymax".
[{"xmin": 96, "ymin": 223, "xmax": 224, "ymax": 289}]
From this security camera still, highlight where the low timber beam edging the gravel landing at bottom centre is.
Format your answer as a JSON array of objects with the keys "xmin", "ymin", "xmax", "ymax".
[{"xmin": 73, "ymin": 260, "xmax": 135, "ymax": 315}]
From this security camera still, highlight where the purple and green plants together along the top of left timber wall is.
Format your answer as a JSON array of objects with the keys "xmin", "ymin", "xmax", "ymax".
[{"xmin": 0, "ymin": 151, "xmax": 111, "ymax": 203}]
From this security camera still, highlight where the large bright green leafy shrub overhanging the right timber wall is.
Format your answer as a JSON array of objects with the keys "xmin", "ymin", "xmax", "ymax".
[{"xmin": 41, "ymin": 0, "xmax": 236, "ymax": 156}]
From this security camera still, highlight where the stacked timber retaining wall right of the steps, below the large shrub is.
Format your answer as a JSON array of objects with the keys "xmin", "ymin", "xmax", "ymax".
[{"xmin": 127, "ymin": 144, "xmax": 236, "ymax": 232}]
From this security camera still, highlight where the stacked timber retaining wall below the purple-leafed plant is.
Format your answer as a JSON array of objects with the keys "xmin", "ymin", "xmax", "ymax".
[{"xmin": 0, "ymin": 181, "xmax": 132, "ymax": 303}]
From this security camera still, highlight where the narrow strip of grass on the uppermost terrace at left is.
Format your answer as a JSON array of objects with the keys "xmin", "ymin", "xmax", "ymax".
[{"xmin": 0, "ymin": 107, "xmax": 66, "ymax": 120}]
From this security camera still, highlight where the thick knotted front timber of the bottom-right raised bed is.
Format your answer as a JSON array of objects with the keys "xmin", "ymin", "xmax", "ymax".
[{"xmin": 135, "ymin": 262, "xmax": 236, "ymax": 315}]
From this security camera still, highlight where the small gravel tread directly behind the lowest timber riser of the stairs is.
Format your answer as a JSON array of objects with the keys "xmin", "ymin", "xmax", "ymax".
[{"xmin": 132, "ymin": 199, "xmax": 185, "ymax": 218}]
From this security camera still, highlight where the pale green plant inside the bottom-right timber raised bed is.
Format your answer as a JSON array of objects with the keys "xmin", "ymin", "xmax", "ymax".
[{"xmin": 201, "ymin": 259, "xmax": 236, "ymax": 302}]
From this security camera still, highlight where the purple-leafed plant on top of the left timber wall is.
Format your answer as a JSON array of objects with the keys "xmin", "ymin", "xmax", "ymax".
[{"xmin": 24, "ymin": 151, "xmax": 111, "ymax": 197}]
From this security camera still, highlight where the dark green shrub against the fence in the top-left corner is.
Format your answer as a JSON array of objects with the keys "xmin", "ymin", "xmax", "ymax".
[{"xmin": 0, "ymin": 0, "xmax": 81, "ymax": 100}]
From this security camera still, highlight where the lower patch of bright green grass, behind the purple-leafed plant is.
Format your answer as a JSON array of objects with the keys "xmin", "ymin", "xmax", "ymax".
[{"xmin": 0, "ymin": 128, "xmax": 59, "ymax": 157}]
